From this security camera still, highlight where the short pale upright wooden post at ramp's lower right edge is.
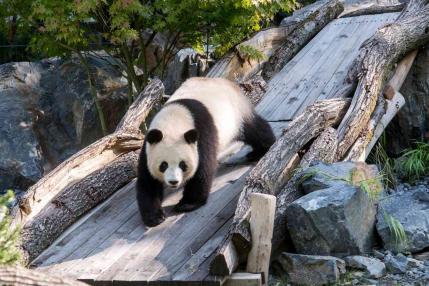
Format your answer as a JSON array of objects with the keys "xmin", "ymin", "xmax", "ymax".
[{"xmin": 246, "ymin": 193, "xmax": 276, "ymax": 285}]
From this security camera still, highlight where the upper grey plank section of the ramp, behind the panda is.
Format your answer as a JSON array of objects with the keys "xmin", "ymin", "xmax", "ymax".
[{"xmin": 257, "ymin": 13, "xmax": 399, "ymax": 121}]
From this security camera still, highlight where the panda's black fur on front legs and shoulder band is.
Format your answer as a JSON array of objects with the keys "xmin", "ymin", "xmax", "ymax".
[{"xmin": 137, "ymin": 99, "xmax": 218, "ymax": 226}]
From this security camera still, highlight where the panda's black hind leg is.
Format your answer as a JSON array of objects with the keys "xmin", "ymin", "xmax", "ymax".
[{"xmin": 241, "ymin": 113, "xmax": 276, "ymax": 161}]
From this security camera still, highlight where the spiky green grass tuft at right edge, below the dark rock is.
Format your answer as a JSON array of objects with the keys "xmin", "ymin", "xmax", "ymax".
[{"xmin": 399, "ymin": 142, "xmax": 429, "ymax": 182}]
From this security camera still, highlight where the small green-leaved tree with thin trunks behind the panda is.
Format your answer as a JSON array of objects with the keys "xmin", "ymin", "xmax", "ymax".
[{"xmin": 22, "ymin": 0, "xmax": 295, "ymax": 134}]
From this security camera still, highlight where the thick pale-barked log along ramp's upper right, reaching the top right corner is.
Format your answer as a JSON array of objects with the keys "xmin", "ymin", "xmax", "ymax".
[{"xmin": 337, "ymin": 0, "xmax": 429, "ymax": 158}]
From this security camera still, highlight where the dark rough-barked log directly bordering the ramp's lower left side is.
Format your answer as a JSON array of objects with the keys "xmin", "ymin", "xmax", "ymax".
[{"xmin": 21, "ymin": 151, "xmax": 139, "ymax": 262}]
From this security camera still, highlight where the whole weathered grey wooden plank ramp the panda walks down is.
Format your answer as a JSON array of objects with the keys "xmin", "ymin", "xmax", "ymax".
[{"xmin": 33, "ymin": 13, "xmax": 398, "ymax": 285}]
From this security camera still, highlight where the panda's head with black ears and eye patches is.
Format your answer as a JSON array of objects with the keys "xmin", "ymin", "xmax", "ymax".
[{"xmin": 146, "ymin": 129, "xmax": 198, "ymax": 188}]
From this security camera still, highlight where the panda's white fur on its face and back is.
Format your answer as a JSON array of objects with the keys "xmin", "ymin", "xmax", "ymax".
[{"xmin": 146, "ymin": 78, "xmax": 253, "ymax": 186}]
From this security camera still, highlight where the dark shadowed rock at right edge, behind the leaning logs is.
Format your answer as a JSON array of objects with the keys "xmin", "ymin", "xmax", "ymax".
[{"xmin": 386, "ymin": 46, "xmax": 429, "ymax": 155}]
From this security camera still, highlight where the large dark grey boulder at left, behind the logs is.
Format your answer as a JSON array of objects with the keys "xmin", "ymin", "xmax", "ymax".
[{"xmin": 0, "ymin": 54, "xmax": 127, "ymax": 191}]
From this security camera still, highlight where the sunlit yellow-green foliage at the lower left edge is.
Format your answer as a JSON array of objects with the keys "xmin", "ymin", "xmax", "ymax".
[{"xmin": 0, "ymin": 191, "xmax": 20, "ymax": 265}]
